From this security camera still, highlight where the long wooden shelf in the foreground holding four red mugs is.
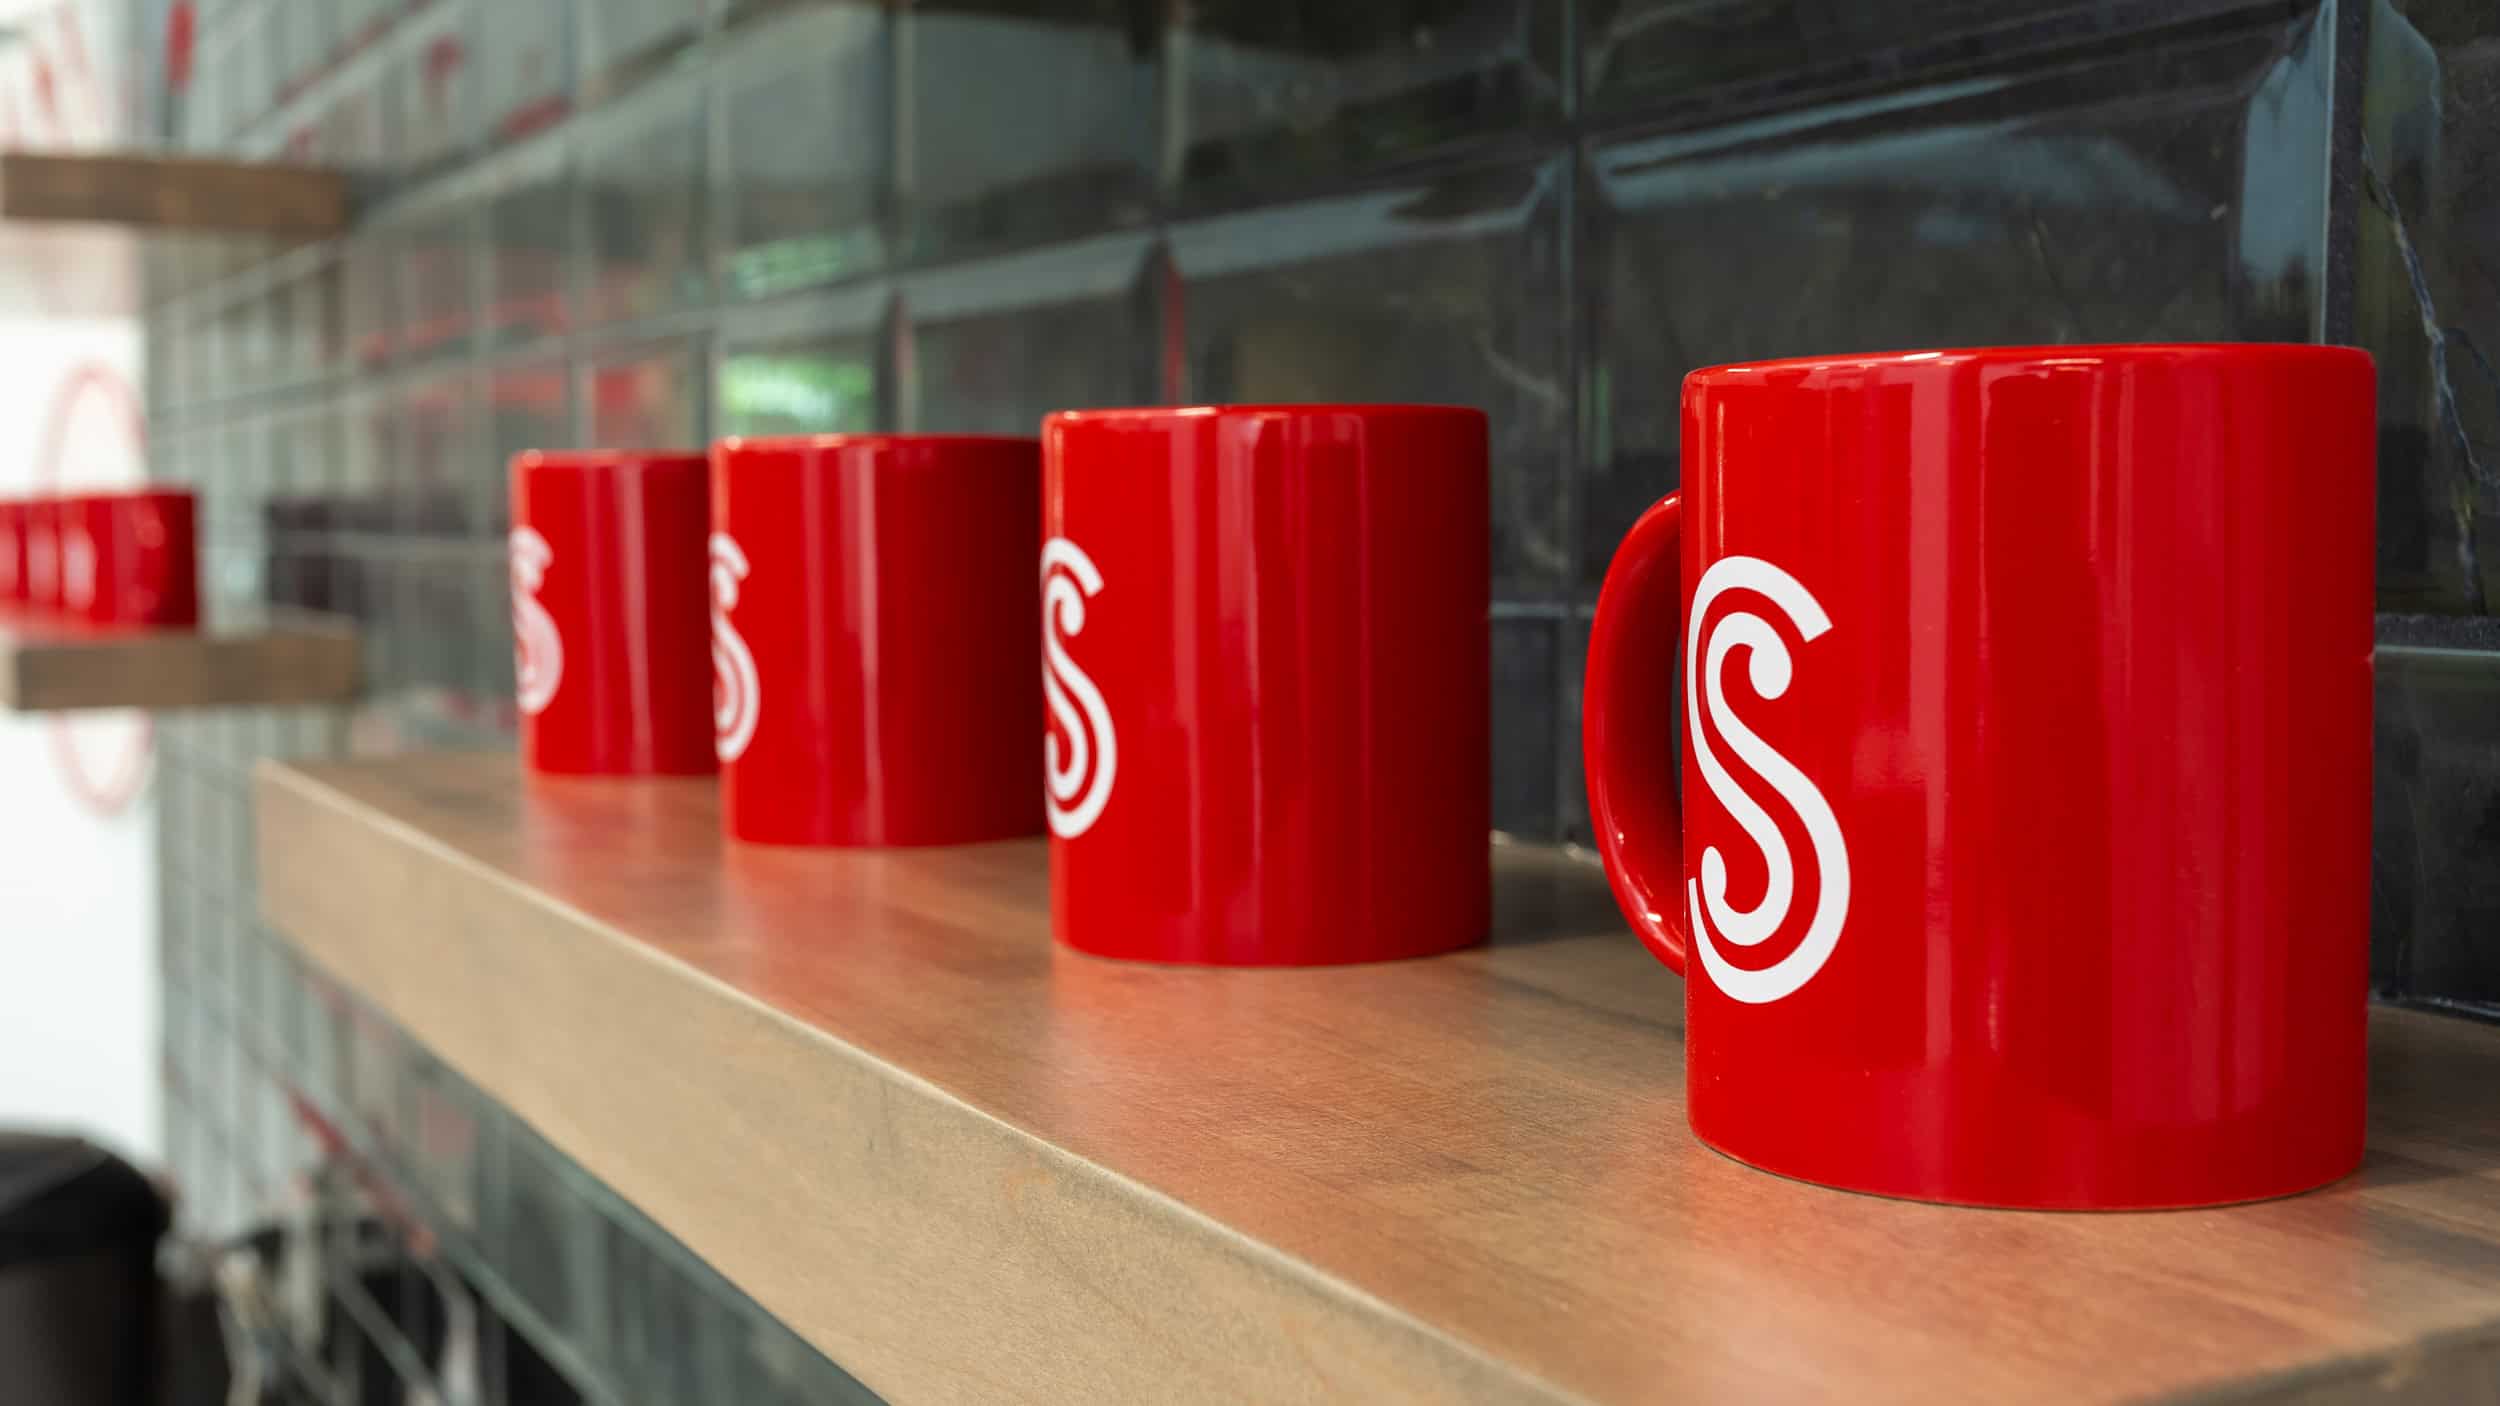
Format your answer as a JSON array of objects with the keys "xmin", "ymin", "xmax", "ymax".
[{"xmin": 258, "ymin": 756, "xmax": 2500, "ymax": 1403}]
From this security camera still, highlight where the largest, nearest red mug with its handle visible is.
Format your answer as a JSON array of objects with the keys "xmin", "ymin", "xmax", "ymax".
[{"xmin": 1583, "ymin": 345, "xmax": 2375, "ymax": 1208}]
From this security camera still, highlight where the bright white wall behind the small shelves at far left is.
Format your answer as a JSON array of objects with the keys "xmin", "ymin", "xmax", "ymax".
[{"xmin": 0, "ymin": 0, "xmax": 160, "ymax": 1163}]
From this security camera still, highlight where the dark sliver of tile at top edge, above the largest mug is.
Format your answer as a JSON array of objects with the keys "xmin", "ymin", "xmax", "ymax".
[{"xmin": 1578, "ymin": 0, "xmax": 2280, "ymax": 115}]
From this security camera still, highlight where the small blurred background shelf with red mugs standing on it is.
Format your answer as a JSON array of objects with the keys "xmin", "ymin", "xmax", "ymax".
[{"xmin": 0, "ymin": 615, "xmax": 358, "ymax": 713}]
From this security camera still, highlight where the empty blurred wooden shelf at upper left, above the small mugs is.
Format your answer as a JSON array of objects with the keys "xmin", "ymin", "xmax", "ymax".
[{"xmin": 0, "ymin": 153, "xmax": 350, "ymax": 240}]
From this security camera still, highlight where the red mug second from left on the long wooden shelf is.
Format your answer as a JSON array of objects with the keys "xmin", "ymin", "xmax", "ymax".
[{"xmin": 710, "ymin": 435, "xmax": 1043, "ymax": 846}]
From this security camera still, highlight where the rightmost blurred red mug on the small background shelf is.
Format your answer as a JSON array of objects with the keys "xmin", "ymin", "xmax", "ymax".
[{"xmin": 58, "ymin": 488, "xmax": 200, "ymax": 628}]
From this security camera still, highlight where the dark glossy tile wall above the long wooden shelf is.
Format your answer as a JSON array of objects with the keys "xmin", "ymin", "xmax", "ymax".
[{"xmin": 150, "ymin": 0, "xmax": 2500, "ymax": 1330}]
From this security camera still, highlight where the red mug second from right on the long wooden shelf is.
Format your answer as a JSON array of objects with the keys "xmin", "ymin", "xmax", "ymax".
[{"xmin": 1043, "ymin": 405, "xmax": 1490, "ymax": 966}]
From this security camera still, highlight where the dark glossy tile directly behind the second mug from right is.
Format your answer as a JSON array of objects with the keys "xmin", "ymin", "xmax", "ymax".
[{"xmin": 1165, "ymin": 163, "xmax": 1570, "ymax": 600}]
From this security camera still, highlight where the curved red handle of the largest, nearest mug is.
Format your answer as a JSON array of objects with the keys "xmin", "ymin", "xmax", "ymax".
[{"xmin": 1580, "ymin": 493, "xmax": 1690, "ymax": 976}]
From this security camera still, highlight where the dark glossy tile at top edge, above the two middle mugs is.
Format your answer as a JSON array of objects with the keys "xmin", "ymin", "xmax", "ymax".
[{"xmin": 895, "ymin": 0, "xmax": 1158, "ymax": 263}]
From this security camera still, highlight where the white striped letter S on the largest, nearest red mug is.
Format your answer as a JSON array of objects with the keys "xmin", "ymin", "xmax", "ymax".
[{"xmin": 1685, "ymin": 555, "xmax": 1850, "ymax": 1006}]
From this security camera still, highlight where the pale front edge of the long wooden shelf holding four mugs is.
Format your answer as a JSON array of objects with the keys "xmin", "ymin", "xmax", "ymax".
[{"xmin": 255, "ymin": 758, "xmax": 1570, "ymax": 1401}]
